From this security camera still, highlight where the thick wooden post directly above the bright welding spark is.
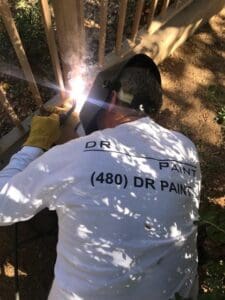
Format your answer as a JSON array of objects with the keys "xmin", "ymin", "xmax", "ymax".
[{"xmin": 52, "ymin": 0, "xmax": 80, "ymax": 88}]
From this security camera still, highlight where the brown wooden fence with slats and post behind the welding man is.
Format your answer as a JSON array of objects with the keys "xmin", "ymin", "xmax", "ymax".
[{"xmin": 0, "ymin": 0, "xmax": 224, "ymax": 164}]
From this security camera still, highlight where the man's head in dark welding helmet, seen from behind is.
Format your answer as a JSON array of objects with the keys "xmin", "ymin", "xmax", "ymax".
[{"xmin": 81, "ymin": 54, "xmax": 162, "ymax": 134}]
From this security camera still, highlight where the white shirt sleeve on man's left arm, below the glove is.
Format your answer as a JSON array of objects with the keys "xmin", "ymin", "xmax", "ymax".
[{"xmin": 0, "ymin": 147, "xmax": 45, "ymax": 225}]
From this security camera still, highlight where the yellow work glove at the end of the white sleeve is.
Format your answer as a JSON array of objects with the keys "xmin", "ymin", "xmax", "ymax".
[{"xmin": 24, "ymin": 114, "xmax": 60, "ymax": 150}]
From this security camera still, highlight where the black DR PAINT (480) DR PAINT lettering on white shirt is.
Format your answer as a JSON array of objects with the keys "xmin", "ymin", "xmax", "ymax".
[{"xmin": 84, "ymin": 140, "xmax": 197, "ymax": 197}]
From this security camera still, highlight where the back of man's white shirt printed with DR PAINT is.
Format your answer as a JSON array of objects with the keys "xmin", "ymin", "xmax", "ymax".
[{"xmin": 37, "ymin": 118, "xmax": 200, "ymax": 300}]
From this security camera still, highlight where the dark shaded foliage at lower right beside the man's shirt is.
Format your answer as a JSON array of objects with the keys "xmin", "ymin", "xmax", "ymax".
[{"xmin": 199, "ymin": 205, "xmax": 225, "ymax": 300}]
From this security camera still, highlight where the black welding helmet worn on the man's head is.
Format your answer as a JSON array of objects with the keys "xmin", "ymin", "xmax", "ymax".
[{"xmin": 80, "ymin": 54, "xmax": 161, "ymax": 134}]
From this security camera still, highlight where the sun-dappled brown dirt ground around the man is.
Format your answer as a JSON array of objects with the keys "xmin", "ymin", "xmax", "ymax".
[{"xmin": 0, "ymin": 10, "xmax": 225, "ymax": 300}]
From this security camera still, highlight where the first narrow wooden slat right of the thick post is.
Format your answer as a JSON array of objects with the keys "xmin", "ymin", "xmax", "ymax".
[{"xmin": 98, "ymin": 0, "xmax": 108, "ymax": 66}]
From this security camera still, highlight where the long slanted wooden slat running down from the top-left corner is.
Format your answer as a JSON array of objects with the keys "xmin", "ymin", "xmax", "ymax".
[{"xmin": 0, "ymin": 0, "xmax": 42, "ymax": 106}]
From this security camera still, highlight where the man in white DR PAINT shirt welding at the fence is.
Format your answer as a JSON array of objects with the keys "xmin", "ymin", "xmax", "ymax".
[{"xmin": 0, "ymin": 54, "xmax": 201, "ymax": 300}]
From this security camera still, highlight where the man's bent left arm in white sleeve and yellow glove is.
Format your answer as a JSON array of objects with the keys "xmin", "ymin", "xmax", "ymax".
[{"xmin": 0, "ymin": 114, "xmax": 60, "ymax": 225}]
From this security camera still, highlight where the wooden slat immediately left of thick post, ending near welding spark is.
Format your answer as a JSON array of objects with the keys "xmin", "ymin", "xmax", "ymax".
[{"xmin": 40, "ymin": 0, "xmax": 64, "ymax": 99}]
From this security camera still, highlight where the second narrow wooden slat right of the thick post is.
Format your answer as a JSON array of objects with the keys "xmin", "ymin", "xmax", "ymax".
[{"xmin": 116, "ymin": 0, "xmax": 127, "ymax": 55}]
